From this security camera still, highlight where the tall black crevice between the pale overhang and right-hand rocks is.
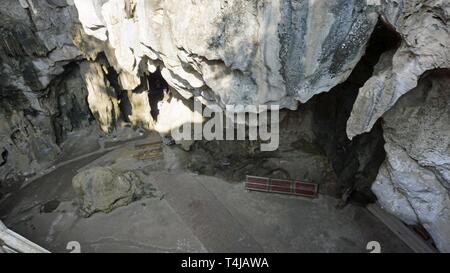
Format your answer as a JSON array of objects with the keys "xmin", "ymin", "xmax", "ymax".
[{"xmin": 308, "ymin": 19, "xmax": 401, "ymax": 206}]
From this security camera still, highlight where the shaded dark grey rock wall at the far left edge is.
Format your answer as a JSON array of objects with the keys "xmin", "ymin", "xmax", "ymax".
[{"xmin": 0, "ymin": 0, "xmax": 89, "ymax": 180}]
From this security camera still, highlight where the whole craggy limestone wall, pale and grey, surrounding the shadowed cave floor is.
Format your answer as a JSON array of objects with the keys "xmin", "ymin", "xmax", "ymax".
[{"xmin": 0, "ymin": 0, "xmax": 450, "ymax": 251}]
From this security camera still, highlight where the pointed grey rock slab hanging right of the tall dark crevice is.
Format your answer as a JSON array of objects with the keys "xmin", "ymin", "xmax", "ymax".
[{"xmin": 347, "ymin": 0, "xmax": 450, "ymax": 138}]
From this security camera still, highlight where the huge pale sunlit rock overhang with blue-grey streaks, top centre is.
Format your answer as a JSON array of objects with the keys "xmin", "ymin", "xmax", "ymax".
[{"xmin": 74, "ymin": 0, "xmax": 378, "ymax": 109}]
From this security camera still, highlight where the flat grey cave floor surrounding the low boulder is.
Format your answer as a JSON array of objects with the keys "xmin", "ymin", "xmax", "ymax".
[{"xmin": 0, "ymin": 131, "xmax": 411, "ymax": 253}]
